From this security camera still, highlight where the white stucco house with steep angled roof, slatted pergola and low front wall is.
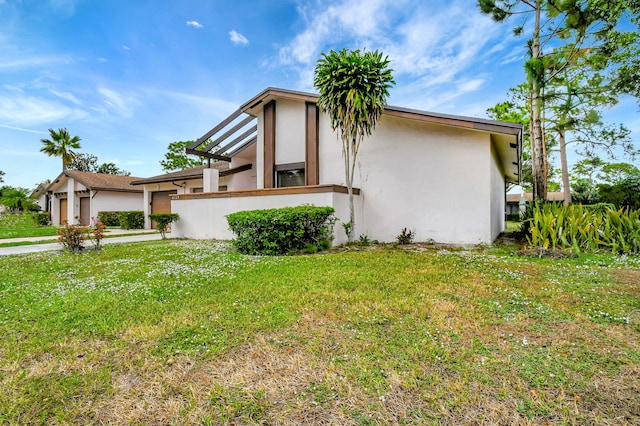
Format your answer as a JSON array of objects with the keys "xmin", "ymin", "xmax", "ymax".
[{"xmin": 171, "ymin": 88, "xmax": 522, "ymax": 244}]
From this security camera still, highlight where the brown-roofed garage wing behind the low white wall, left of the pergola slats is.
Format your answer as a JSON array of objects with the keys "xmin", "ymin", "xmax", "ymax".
[{"xmin": 131, "ymin": 161, "xmax": 251, "ymax": 228}]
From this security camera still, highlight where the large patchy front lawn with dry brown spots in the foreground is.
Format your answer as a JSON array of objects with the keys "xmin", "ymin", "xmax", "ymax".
[{"xmin": 0, "ymin": 240, "xmax": 640, "ymax": 425}]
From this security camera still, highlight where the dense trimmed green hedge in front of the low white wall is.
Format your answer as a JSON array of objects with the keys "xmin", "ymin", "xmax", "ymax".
[{"xmin": 227, "ymin": 206, "xmax": 336, "ymax": 255}]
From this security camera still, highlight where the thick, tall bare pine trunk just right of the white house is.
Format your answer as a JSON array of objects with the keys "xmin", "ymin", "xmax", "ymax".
[{"xmin": 531, "ymin": 0, "xmax": 547, "ymax": 200}]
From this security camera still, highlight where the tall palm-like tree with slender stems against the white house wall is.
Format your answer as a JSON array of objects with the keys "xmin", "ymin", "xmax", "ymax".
[{"xmin": 313, "ymin": 49, "xmax": 395, "ymax": 242}]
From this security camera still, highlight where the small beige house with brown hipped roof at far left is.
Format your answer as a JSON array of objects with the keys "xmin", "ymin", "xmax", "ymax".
[{"xmin": 47, "ymin": 170, "xmax": 143, "ymax": 225}]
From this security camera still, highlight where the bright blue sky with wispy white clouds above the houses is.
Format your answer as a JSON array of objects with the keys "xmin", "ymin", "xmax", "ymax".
[{"xmin": 0, "ymin": 0, "xmax": 640, "ymax": 188}]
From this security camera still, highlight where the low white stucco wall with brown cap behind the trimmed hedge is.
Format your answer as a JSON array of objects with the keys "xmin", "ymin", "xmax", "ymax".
[{"xmin": 171, "ymin": 192, "xmax": 360, "ymax": 244}]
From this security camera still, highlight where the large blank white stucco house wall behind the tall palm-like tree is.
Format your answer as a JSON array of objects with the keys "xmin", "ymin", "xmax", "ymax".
[{"xmin": 319, "ymin": 111, "xmax": 493, "ymax": 244}]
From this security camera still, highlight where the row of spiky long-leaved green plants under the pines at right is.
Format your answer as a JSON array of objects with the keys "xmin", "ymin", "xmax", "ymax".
[{"xmin": 527, "ymin": 203, "xmax": 640, "ymax": 254}]
